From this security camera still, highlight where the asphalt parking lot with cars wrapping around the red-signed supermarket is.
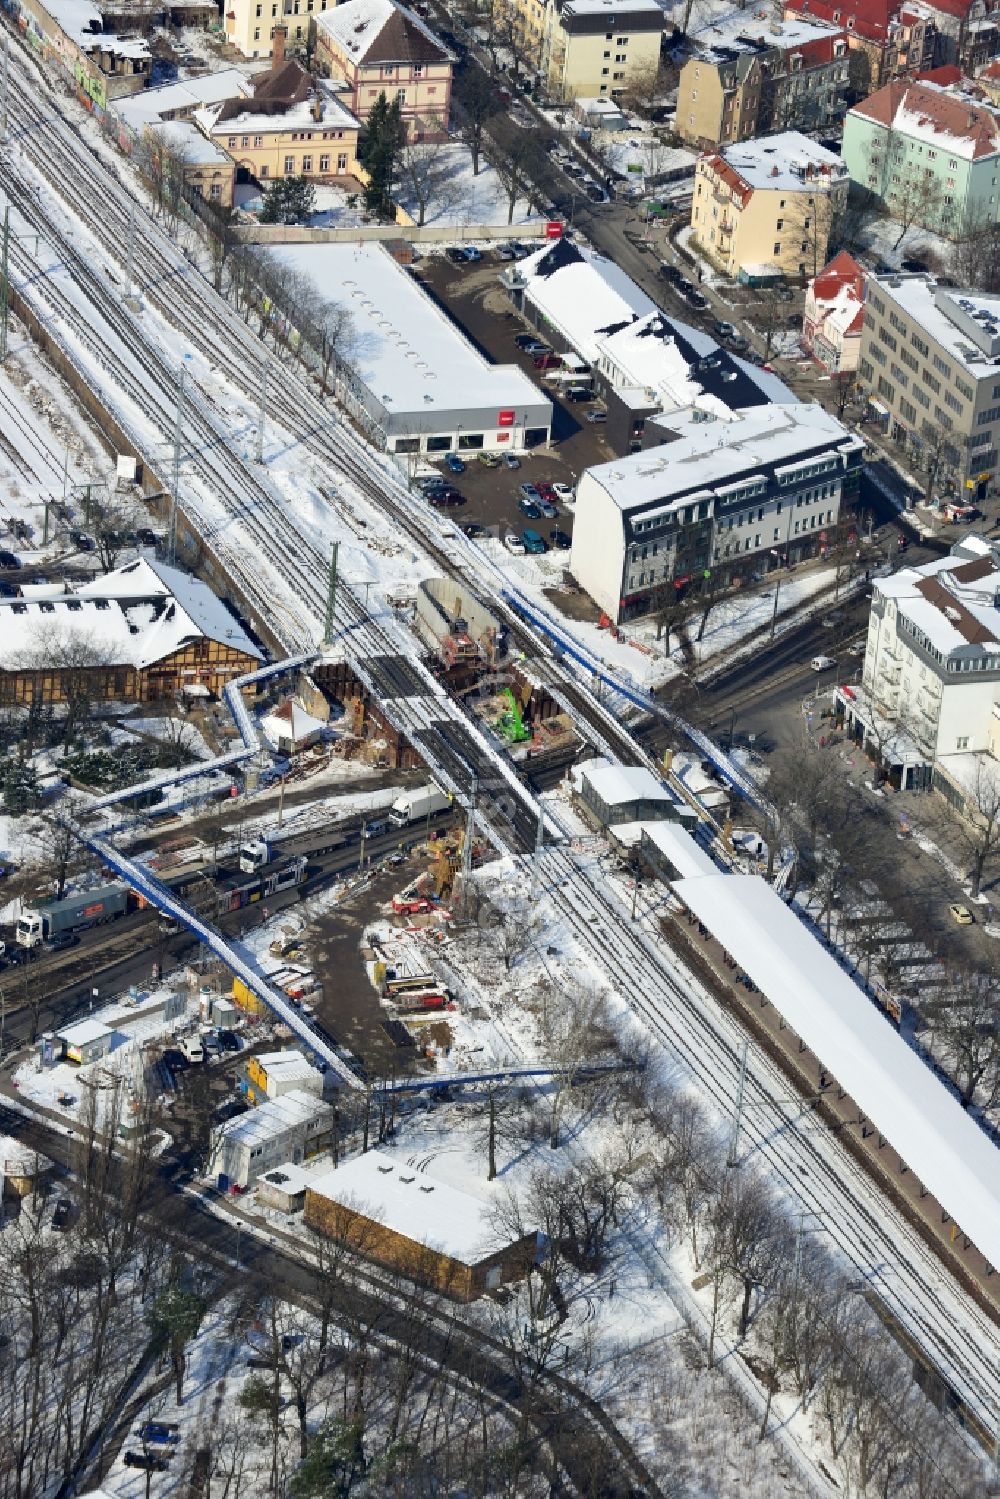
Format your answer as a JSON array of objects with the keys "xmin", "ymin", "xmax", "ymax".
[{"xmin": 407, "ymin": 253, "xmax": 615, "ymax": 554}]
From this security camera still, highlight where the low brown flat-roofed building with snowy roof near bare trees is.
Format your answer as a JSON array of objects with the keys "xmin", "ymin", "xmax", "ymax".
[{"xmin": 306, "ymin": 1150, "xmax": 537, "ymax": 1301}]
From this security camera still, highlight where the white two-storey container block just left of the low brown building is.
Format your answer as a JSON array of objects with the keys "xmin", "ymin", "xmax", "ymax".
[{"xmin": 208, "ymin": 1088, "xmax": 333, "ymax": 1192}]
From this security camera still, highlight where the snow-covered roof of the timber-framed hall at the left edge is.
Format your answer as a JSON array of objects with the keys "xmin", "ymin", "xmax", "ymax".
[{"xmin": 0, "ymin": 556, "xmax": 261, "ymax": 670}]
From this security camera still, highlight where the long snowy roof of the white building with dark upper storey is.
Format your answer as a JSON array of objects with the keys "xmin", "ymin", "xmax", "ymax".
[{"xmin": 588, "ymin": 402, "xmax": 861, "ymax": 511}]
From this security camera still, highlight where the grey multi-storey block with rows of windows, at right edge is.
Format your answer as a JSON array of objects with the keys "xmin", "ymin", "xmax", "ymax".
[{"xmin": 858, "ymin": 276, "xmax": 1000, "ymax": 504}]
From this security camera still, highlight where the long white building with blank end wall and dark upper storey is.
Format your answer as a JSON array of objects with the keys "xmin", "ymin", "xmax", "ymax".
[{"xmin": 570, "ymin": 403, "xmax": 864, "ymax": 622}]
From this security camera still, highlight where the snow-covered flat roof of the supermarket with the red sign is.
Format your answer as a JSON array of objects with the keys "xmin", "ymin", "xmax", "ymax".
[{"xmin": 271, "ymin": 242, "xmax": 547, "ymax": 421}]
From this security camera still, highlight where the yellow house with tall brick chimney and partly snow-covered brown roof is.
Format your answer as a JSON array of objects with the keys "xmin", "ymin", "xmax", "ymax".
[{"xmin": 196, "ymin": 36, "xmax": 360, "ymax": 183}]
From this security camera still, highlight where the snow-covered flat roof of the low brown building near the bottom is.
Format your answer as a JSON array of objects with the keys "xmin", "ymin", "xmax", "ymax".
[{"xmin": 309, "ymin": 1150, "xmax": 515, "ymax": 1265}]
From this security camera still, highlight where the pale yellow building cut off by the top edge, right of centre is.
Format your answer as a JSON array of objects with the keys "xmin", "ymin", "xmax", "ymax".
[{"xmin": 513, "ymin": 0, "xmax": 664, "ymax": 100}]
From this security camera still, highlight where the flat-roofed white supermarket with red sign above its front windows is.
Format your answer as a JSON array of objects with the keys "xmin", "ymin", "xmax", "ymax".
[{"xmin": 274, "ymin": 244, "xmax": 552, "ymax": 456}]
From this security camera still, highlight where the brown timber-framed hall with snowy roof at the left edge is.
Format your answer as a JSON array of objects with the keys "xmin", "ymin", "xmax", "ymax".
[{"xmin": 0, "ymin": 556, "xmax": 262, "ymax": 705}]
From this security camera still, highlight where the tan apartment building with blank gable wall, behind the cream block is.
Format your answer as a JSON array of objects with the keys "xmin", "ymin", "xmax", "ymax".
[{"xmin": 676, "ymin": 10, "xmax": 847, "ymax": 150}]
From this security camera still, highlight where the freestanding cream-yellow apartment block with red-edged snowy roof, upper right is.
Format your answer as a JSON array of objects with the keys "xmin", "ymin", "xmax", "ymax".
[{"xmin": 691, "ymin": 130, "xmax": 849, "ymax": 282}]
